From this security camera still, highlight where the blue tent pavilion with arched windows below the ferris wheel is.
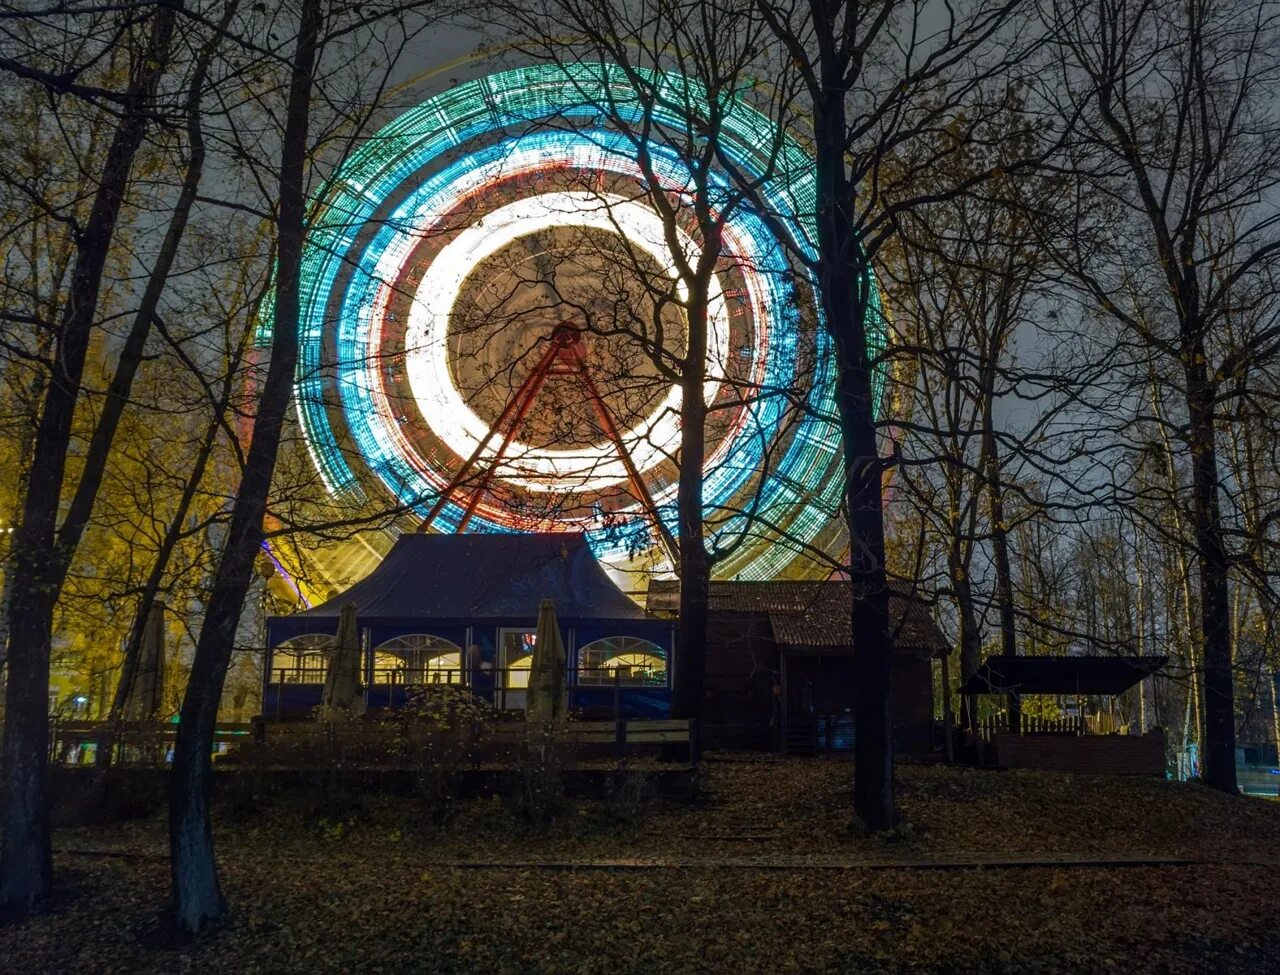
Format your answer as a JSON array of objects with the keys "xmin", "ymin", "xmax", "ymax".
[{"xmin": 262, "ymin": 532, "xmax": 675, "ymax": 718}]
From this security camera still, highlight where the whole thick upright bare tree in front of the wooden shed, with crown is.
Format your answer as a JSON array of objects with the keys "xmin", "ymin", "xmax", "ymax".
[{"xmin": 742, "ymin": 0, "xmax": 1021, "ymax": 829}]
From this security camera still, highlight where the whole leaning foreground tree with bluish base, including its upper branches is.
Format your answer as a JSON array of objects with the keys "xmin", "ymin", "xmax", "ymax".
[{"xmin": 169, "ymin": 0, "xmax": 453, "ymax": 934}]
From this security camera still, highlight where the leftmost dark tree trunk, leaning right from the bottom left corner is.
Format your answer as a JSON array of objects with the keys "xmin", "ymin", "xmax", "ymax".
[{"xmin": 0, "ymin": 6, "xmax": 175, "ymax": 912}]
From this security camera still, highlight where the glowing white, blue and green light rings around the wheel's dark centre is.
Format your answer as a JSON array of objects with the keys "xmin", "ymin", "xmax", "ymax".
[{"xmin": 273, "ymin": 64, "xmax": 883, "ymax": 578}]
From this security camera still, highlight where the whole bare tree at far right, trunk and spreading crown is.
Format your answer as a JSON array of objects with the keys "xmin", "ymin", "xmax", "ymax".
[{"xmin": 1043, "ymin": 0, "xmax": 1280, "ymax": 792}]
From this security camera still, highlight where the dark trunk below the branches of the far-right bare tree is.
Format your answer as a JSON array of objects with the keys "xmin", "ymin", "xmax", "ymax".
[{"xmin": 1184, "ymin": 343, "xmax": 1236, "ymax": 793}]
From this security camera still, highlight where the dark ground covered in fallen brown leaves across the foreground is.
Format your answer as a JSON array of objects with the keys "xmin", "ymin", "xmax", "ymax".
[{"xmin": 0, "ymin": 755, "xmax": 1280, "ymax": 975}]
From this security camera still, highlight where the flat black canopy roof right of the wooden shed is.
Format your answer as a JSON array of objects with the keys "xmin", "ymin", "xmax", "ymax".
[{"xmin": 960, "ymin": 656, "xmax": 1169, "ymax": 695}]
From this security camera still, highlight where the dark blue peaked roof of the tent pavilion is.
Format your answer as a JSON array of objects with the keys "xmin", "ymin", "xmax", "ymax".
[{"xmin": 278, "ymin": 532, "xmax": 654, "ymax": 622}]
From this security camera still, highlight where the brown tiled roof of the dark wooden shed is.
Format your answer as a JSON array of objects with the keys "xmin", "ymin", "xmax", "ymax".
[{"xmin": 645, "ymin": 580, "xmax": 950, "ymax": 656}]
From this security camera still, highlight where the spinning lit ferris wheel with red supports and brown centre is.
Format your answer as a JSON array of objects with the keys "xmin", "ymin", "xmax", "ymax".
[{"xmin": 273, "ymin": 64, "xmax": 883, "ymax": 578}]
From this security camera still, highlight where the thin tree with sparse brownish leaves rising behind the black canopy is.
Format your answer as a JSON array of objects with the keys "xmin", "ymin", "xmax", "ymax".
[{"xmin": 883, "ymin": 98, "xmax": 1110, "ymax": 729}]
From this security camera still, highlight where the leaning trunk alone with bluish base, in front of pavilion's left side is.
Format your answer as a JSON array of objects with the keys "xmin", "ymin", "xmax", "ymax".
[{"xmin": 169, "ymin": 0, "xmax": 323, "ymax": 934}]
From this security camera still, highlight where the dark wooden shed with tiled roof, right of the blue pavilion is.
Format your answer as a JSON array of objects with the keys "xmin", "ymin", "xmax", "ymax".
[{"xmin": 646, "ymin": 580, "xmax": 950, "ymax": 754}]
